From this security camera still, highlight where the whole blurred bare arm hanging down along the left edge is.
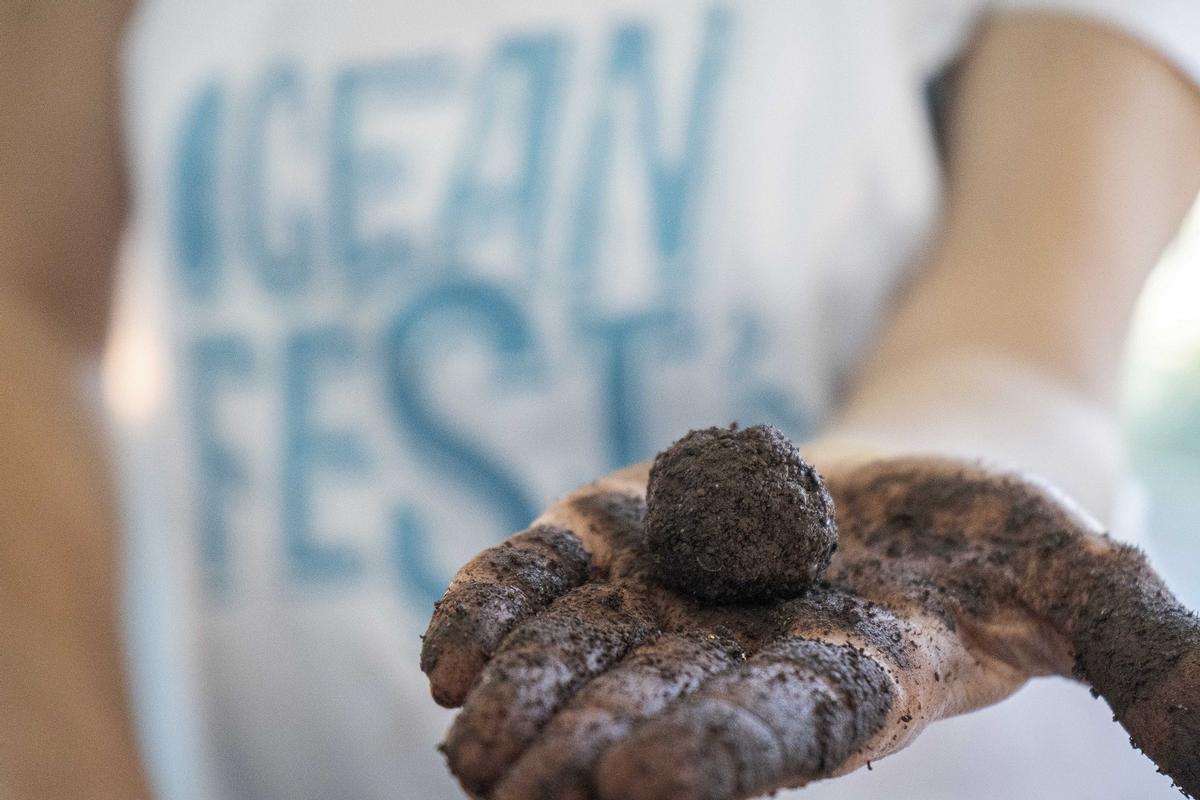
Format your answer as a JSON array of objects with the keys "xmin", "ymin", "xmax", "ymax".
[{"xmin": 0, "ymin": 0, "xmax": 149, "ymax": 800}]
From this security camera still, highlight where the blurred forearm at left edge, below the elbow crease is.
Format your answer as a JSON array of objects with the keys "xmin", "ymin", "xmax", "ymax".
[{"xmin": 0, "ymin": 291, "xmax": 149, "ymax": 800}]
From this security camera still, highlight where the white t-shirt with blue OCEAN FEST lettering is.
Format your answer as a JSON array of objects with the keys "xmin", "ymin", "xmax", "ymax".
[{"xmin": 110, "ymin": 0, "xmax": 1200, "ymax": 800}]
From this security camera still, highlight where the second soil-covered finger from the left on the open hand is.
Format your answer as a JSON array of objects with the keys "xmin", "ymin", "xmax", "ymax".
[{"xmin": 444, "ymin": 584, "xmax": 656, "ymax": 795}]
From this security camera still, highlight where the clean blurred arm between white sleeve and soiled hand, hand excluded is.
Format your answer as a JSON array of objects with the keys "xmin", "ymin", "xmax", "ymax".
[{"xmin": 829, "ymin": 16, "xmax": 1200, "ymax": 519}]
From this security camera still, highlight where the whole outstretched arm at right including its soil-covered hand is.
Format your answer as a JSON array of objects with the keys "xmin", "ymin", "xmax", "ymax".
[{"xmin": 422, "ymin": 16, "xmax": 1200, "ymax": 799}]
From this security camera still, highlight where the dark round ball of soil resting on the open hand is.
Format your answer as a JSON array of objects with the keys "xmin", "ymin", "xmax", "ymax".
[{"xmin": 644, "ymin": 423, "xmax": 838, "ymax": 602}]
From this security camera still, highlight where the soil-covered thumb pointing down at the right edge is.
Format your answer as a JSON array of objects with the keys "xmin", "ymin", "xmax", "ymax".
[{"xmin": 907, "ymin": 462, "xmax": 1200, "ymax": 794}]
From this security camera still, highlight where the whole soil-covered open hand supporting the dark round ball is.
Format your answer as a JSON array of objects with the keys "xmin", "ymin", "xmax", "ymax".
[{"xmin": 421, "ymin": 428, "xmax": 1200, "ymax": 800}]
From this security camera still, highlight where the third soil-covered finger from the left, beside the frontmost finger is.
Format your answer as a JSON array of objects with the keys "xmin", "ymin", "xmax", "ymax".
[{"xmin": 493, "ymin": 634, "xmax": 745, "ymax": 800}]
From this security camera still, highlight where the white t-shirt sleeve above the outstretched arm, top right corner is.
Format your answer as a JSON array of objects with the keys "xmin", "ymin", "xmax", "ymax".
[{"xmin": 990, "ymin": 0, "xmax": 1200, "ymax": 86}]
